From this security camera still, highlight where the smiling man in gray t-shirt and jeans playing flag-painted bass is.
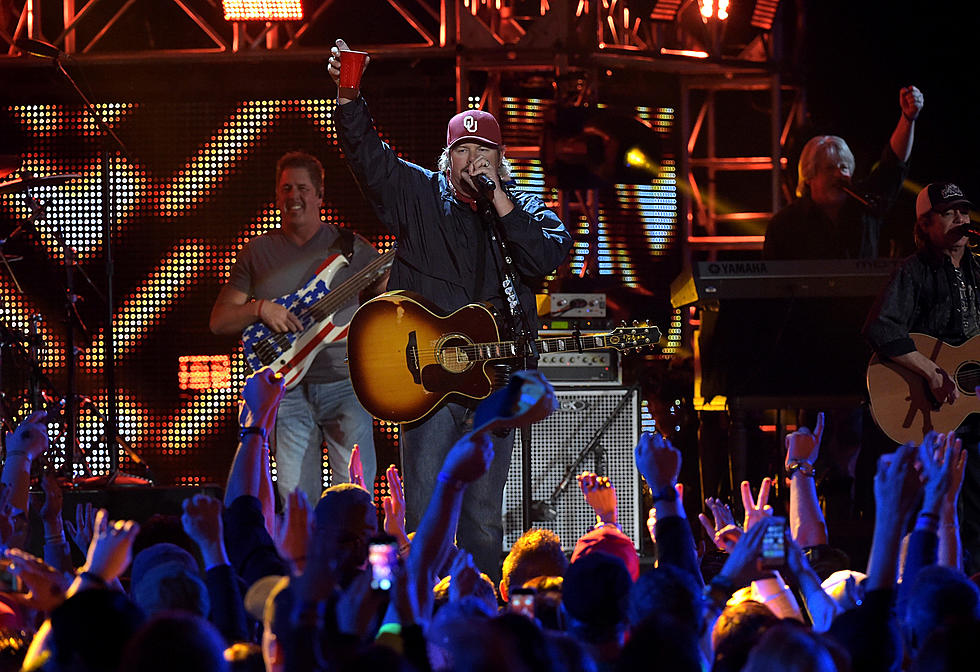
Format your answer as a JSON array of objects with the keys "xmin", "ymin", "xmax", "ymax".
[{"xmin": 210, "ymin": 152, "xmax": 378, "ymax": 503}]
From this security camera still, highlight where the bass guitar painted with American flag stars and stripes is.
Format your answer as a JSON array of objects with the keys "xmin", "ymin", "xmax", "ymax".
[{"xmin": 242, "ymin": 250, "xmax": 395, "ymax": 389}]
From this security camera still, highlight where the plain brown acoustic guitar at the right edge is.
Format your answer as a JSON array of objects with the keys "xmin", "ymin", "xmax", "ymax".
[{"xmin": 867, "ymin": 334, "xmax": 980, "ymax": 443}]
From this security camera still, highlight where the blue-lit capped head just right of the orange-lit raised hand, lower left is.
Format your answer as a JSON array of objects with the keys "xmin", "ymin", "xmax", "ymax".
[{"xmin": 130, "ymin": 543, "xmax": 211, "ymax": 616}]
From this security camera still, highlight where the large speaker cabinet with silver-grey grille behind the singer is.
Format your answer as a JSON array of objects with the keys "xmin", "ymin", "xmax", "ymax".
[{"xmin": 504, "ymin": 388, "xmax": 645, "ymax": 552}]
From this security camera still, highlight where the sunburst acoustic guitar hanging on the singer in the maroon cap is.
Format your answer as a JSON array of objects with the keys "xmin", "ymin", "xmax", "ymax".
[{"xmin": 347, "ymin": 291, "xmax": 660, "ymax": 422}]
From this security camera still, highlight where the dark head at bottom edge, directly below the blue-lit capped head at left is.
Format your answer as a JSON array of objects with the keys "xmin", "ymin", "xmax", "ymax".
[{"xmin": 119, "ymin": 612, "xmax": 228, "ymax": 672}]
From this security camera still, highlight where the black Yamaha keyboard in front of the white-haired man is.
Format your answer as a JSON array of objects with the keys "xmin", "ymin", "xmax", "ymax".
[{"xmin": 671, "ymin": 259, "xmax": 902, "ymax": 307}]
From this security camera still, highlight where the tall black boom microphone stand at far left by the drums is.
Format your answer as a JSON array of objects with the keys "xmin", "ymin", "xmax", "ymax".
[{"xmin": 17, "ymin": 40, "xmax": 136, "ymax": 486}]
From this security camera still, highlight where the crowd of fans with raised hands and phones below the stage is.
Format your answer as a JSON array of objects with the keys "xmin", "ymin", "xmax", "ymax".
[{"xmin": 0, "ymin": 370, "xmax": 980, "ymax": 672}]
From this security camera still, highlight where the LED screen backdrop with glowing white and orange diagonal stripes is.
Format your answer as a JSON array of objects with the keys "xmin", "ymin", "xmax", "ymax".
[{"xmin": 0, "ymin": 90, "xmax": 679, "ymax": 498}]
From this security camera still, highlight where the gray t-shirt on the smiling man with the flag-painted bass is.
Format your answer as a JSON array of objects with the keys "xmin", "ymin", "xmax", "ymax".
[{"xmin": 228, "ymin": 223, "xmax": 378, "ymax": 383}]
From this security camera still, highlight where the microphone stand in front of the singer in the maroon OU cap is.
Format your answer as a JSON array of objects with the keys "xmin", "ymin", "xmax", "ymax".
[{"xmin": 477, "ymin": 180, "xmax": 538, "ymax": 532}]
